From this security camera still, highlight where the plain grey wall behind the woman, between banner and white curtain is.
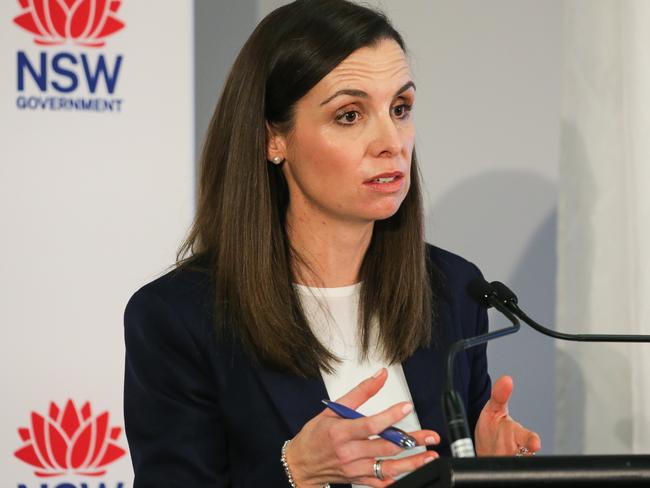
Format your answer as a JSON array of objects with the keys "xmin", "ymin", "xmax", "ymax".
[{"xmin": 196, "ymin": 0, "xmax": 561, "ymax": 453}]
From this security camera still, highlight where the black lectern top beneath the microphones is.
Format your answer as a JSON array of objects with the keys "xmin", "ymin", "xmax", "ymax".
[{"xmin": 392, "ymin": 455, "xmax": 650, "ymax": 488}]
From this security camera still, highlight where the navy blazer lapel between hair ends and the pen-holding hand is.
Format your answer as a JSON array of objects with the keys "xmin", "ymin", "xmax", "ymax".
[{"xmin": 256, "ymin": 368, "xmax": 328, "ymax": 437}]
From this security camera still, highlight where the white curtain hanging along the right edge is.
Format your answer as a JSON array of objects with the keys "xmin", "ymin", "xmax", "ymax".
[{"xmin": 556, "ymin": 0, "xmax": 650, "ymax": 454}]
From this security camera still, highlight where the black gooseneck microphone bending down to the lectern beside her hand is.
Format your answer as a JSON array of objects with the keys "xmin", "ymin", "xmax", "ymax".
[{"xmin": 442, "ymin": 278, "xmax": 520, "ymax": 457}]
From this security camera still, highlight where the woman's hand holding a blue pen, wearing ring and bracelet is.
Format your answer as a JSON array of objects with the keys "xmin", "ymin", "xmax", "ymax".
[{"xmin": 286, "ymin": 368, "xmax": 440, "ymax": 488}]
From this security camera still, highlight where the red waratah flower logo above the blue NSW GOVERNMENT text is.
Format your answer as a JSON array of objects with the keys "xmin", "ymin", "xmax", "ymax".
[{"xmin": 14, "ymin": 0, "xmax": 124, "ymax": 47}]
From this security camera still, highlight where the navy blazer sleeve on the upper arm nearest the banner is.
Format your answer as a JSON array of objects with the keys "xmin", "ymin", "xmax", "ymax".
[{"xmin": 124, "ymin": 287, "xmax": 231, "ymax": 488}]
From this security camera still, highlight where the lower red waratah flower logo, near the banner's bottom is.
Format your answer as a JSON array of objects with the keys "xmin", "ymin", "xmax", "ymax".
[{"xmin": 14, "ymin": 400, "xmax": 126, "ymax": 477}]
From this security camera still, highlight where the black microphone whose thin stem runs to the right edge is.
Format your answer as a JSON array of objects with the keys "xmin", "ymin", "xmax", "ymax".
[{"xmin": 488, "ymin": 281, "xmax": 650, "ymax": 342}]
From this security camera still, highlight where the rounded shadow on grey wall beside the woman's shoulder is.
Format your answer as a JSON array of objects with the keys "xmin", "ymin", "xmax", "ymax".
[{"xmin": 426, "ymin": 171, "xmax": 557, "ymax": 454}]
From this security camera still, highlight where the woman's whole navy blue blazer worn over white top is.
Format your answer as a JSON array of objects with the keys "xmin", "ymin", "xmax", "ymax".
[{"xmin": 124, "ymin": 246, "xmax": 491, "ymax": 488}]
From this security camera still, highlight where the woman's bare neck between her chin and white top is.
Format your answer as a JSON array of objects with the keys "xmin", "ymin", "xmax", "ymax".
[{"xmin": 286, "ymin": 208, "xmax": 374, "ymax": 288}]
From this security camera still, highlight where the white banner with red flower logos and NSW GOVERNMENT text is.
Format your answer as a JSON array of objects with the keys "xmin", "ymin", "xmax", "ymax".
[{"xmin": 0, "ymin": 0, "xmax": 194, "ymax": 488}]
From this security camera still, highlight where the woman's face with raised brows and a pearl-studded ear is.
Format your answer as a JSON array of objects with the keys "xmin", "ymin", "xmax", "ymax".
[{"xmin": 269, "ymin": 39, "xmax": 415, "ymax": 223}]
